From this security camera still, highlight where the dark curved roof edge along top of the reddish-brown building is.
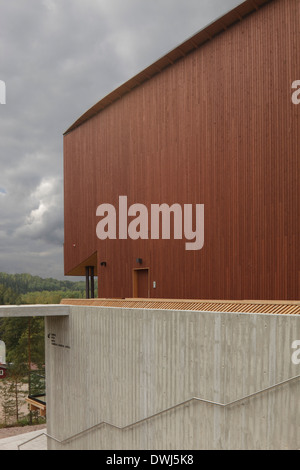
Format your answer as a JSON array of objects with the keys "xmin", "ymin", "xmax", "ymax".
[{"xmin": 64, "ymin": 0, "xmax": 273, "ymax": 135}]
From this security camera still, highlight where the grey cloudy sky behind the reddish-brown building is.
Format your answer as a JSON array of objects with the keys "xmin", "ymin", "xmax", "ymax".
[{"xmin": 0, "ymin": 0, "xmax": 242, "ymax": 280}]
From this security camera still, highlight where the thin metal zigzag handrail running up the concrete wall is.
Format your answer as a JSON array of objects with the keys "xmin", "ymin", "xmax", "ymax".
[{"xmin": 18, "ymin": 375, "xmax": 300, "ymax": 450}]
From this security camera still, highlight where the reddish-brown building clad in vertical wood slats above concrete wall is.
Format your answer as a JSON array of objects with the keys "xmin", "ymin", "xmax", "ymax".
[{"xmin": 64, "ymin": 0, "xmax": 300, "ymax": 300}]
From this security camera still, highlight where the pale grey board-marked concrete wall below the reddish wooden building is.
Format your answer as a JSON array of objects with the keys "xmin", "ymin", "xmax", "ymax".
[{"xmin": 46, "ymin": 306, "xmax": 300, "ymax": 450}]
